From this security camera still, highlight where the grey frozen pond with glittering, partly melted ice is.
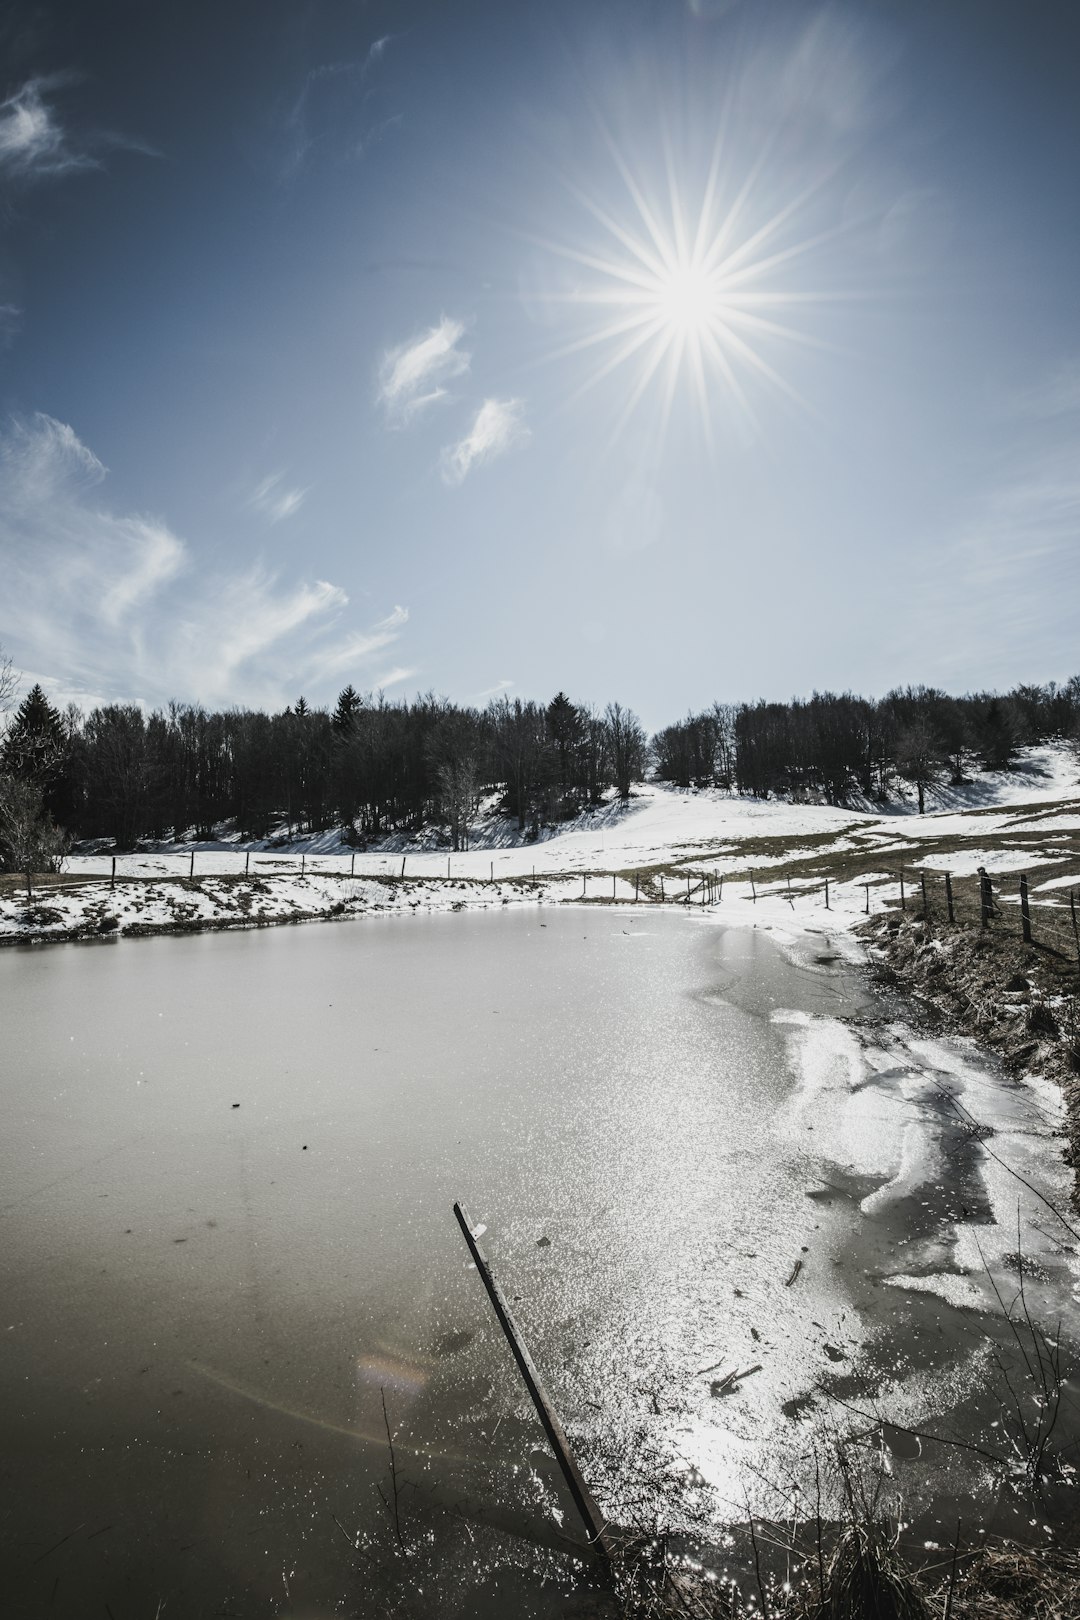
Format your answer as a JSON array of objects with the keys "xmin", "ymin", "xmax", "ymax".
[{"xmin": 0, "ymin": 907, "xmax": 1077, "ymax": 1620}]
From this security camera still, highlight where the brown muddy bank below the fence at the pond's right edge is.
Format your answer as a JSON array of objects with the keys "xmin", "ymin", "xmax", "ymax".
[{"xmin": 858, "ymin": 912, "xmax": 1080, "ymax": 1209}]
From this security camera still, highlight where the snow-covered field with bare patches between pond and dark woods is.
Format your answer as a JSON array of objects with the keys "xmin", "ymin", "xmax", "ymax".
[{"xmin": 0, "ymin": 745, "xmax": 1080, "ymax": 943}]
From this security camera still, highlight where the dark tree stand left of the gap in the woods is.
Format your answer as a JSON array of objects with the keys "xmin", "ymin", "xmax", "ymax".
[{"xmin": 0, "ymin": 660, "xmax": 646, "ymax": 870}]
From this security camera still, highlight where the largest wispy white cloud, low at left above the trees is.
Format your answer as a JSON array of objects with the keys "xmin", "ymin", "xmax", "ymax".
[{"xmin": 0, "ymin": 415, "xmax": 408, "ymax": 706}]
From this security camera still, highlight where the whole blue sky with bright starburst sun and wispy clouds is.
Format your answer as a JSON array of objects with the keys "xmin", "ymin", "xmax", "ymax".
[{"xmin": 0, "ymin": 0, "xmax": 1080, "ymax": 726}]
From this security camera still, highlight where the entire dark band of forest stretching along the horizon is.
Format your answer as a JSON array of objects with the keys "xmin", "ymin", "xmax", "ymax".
[{"xmin": 0, "ymin": 651, "xmax": 1080, "ymax": 870}]
